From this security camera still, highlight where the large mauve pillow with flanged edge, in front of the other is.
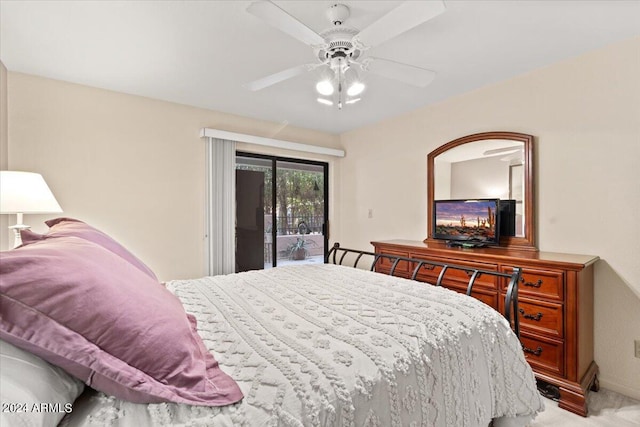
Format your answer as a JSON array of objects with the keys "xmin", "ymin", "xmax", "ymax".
[{"xmin": 0, "ymin": 237, "xmax": 242, "ymax": 406}]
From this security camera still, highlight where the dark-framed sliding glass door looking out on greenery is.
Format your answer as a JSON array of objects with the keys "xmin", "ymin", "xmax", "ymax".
[{"xmin": 236, "ymin": 152, "xmax": 329, "ymax": 271}]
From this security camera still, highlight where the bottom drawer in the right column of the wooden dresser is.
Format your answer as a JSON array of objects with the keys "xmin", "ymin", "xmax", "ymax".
[{"xmin": 520, "ymin": 331, "xmax": 564, "ymax": 375}]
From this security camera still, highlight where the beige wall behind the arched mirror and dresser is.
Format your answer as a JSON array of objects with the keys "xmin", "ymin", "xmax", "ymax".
[{"xmin": 337, "ymin": 39, "xmax": 640, "ymax": 398}]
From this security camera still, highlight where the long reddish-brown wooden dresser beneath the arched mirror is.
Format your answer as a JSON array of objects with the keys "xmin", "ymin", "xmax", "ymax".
[{"xmin": 371, "ymin": 240, "xmax": 598, "ymax": 416}]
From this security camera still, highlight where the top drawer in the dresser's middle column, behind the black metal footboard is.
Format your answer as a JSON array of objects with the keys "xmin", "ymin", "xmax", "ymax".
[{"xmin": 411, "ymin": 254, "xmax": 498, "ymax": 292}]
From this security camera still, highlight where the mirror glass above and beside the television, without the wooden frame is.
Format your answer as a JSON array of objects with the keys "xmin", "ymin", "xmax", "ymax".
[{"xmin": 434, "ymin": 139, "xmax": 525, "ymax": 237}]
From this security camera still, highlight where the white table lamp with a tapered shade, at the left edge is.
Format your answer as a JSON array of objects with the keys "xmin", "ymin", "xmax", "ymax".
[{"xmin": 0, "ymin": 171, "xmax": 62, "ymax": 248}]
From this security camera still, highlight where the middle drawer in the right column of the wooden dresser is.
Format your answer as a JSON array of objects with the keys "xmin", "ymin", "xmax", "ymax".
[{"xmin": 500, "ymin": 293, "xmax": 564, "ymax": 338}]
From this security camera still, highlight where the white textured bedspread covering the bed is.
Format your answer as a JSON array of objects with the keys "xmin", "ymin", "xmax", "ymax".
[{"xmin": 62, "ymin": 264, "xmax": 543, "ymax": 427}]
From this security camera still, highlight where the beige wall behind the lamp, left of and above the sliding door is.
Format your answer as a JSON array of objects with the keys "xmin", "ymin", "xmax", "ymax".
[{"xmin": 8, "ymin": 72, "xmax": 338, "ymax": 280}]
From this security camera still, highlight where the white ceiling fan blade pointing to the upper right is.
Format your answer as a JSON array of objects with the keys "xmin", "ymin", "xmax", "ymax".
[{"xmin": 354, "ymin": 0, "xmax": 445, "ymax": 49}]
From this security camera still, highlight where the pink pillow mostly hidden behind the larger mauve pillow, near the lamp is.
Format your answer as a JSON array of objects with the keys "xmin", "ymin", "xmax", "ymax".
[{"xmin": 21, "ymin": 218, "xmax": 157, "ymax": 280}]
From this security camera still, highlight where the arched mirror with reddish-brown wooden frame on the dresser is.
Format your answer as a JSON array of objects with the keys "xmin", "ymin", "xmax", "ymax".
[{"xmin": 425, "ymin": 132, "xmax": 536, "ymax": 250}]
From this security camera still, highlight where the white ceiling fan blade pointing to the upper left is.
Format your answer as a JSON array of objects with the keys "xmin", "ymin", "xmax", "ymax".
[{"xmin": 247, "ymin": 0, "xmax": 324, "ymax": 46}]
